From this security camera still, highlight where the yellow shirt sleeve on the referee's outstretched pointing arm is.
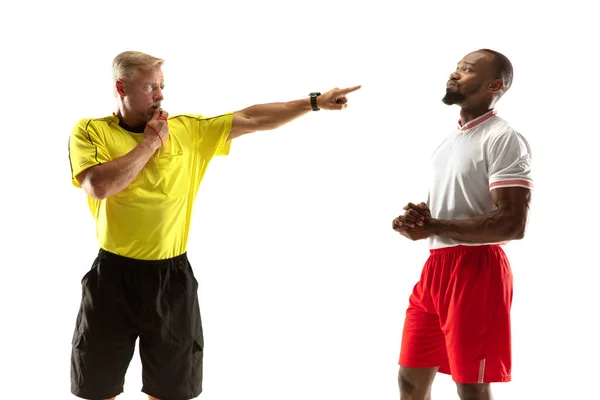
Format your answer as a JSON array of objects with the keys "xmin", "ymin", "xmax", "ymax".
[{"xmin": 196, "ymin": 112, "xmax": 233, "ymax": 156}]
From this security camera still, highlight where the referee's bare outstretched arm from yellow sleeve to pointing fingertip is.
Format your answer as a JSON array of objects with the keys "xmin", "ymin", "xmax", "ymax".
[{"xmin": 227, "ymin": 86, "xmax": 360, "ymax": 140}]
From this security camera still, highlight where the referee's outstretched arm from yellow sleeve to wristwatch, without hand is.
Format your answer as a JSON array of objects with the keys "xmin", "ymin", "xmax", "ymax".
[{"xmin": 227, "ymin": 98, "xmax": 319, "ymax": 140}]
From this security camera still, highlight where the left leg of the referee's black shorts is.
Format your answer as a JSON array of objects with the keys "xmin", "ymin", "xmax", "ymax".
[{"xmin": 71, "ymin": 259, "xmax": 136, "ymax": 399}]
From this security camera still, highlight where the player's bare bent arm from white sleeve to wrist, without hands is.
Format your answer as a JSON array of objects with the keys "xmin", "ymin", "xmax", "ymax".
[{"xmin": 425, "ymin": 187, "xmax": 531, "ymax": 243}]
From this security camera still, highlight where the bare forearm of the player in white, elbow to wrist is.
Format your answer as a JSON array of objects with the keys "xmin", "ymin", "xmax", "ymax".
[{"xmin": 428, "ymin": 210, "xmax": 525, "ymax": 243}]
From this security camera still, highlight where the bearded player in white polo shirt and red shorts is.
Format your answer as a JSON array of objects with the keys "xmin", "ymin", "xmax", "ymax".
[{"xmin": 392, "ymin": 49, "xmax": 533, "ymax": 400}]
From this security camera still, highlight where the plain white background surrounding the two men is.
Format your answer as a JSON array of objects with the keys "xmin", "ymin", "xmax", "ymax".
[{"xmin": 0, "ymin": 0, "xmax": 600, "ymax": 400}]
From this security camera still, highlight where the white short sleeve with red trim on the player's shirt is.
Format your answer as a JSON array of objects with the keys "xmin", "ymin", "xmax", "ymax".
[{"xmin": 488, "ymin": 131, "xmax": 533, "ymax": 190}]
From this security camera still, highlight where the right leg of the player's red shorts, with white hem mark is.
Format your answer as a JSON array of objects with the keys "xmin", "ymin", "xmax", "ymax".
[{"xmin": 442, "ymin": 246, "xmax": 512, "ymax": 384}]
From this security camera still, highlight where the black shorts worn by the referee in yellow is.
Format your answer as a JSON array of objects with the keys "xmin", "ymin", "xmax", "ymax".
[{"xmin": 71, "ymin": 250, "xmax": 204, "ymax": 400}]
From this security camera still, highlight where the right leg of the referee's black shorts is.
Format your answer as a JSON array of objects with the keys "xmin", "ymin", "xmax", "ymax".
[{"xmin": 140, "ymin": 259, "xmax": 204, "ymax": 400}]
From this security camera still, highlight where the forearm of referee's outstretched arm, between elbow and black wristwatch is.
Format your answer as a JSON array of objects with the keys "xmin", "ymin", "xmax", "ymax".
[{"xmin": 243, "ymin": 98, "xmax": 312, "ymax": 131}]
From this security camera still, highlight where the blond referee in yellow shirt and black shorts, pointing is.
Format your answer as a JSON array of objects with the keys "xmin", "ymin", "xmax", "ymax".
[{"xmin": 69, "ymin": 51, "xmax": 360, "ymax": 400}]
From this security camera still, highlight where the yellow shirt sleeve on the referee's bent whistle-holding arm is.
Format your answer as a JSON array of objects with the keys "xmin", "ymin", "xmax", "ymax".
[{"xmin": 69, "ymin": 119, "xmax": 110, "ymax": 187}]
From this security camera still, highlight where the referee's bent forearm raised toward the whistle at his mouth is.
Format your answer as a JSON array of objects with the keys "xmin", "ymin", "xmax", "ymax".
[{"xmin": 81, "ymin": 140, "xmax": 156, "ymax": 200}]
